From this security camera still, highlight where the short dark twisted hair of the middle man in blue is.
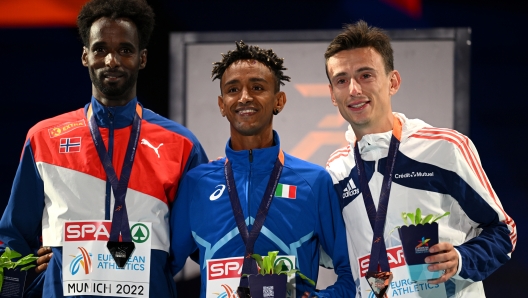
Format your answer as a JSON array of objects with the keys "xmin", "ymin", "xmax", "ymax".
[{"xmin": 211, "ymin": 40, "xmax": 290, "ymax": 92}]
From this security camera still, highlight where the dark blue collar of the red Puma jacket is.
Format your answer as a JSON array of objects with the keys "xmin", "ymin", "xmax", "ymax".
[{"xmin": 84, "ymin": 96, "xmax": 138, "ymax": 129}]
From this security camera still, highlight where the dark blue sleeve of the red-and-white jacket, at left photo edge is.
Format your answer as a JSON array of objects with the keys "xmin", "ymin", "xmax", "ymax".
[{"xmin": 0, "ymin": 139, "xmax": 44, "ymax": 256}]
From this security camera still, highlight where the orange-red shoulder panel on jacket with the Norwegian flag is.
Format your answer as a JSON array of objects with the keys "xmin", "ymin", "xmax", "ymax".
[{"xmin": 26, "ymin": 108, "xmax": 88, "ymax": 140}]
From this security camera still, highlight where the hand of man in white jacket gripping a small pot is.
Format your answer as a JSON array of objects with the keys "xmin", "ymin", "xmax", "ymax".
[{"xmin": 425, "ymin": 242, "xmax": 458, "ymax": 285}]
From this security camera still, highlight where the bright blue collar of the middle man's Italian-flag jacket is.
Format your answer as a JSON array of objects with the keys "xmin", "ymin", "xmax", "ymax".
[{"xmin": 225, "ymin": 131, "xmax": 280, "ymax": 172}]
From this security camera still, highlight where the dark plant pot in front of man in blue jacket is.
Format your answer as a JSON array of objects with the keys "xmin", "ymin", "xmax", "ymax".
[{"xmin": 248, "ymin": 274, "xmax": 288, "ymax": 298}]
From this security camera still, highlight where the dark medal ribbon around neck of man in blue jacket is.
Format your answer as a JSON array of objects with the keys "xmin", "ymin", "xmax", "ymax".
[{"xmin": 224, "ymin": 150, "xmax": 284, "ymax": 287}]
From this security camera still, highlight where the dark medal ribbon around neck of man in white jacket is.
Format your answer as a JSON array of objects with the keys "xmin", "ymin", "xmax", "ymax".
[{"xmin": 354, "ymin": 117, "xmax": 401, "ymax": 272}]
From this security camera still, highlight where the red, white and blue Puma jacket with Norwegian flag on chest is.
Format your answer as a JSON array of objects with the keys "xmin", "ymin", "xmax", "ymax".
[{"xmin": 0, "ymin": 97, "xmax": 207, "ymax": 297}]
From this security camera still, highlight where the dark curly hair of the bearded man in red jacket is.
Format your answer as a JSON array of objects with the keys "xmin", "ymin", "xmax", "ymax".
[{"xmin": 77, "ymin": 0, "xmax": 154, "ymax": 50}]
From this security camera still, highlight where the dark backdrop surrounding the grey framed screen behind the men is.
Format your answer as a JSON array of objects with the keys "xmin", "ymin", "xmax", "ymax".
[{"xmin": 0, "ymin": 0, "xmax": 528, "ymax": 297}]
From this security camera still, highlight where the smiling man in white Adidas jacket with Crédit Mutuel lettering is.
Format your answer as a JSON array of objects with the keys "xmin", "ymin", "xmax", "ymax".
[{"xmin": 325, "ymin": 21, "xmax": 517, "ymax": 297}]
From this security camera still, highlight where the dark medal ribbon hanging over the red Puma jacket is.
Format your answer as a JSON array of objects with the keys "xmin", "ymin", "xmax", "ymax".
[{"xmin": 87, "ymin": 104, "xmax": 142, "ymax": 242}]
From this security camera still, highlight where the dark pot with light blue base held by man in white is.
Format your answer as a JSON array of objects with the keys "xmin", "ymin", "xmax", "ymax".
[{"xmin": 398, "ymin": 222, "xmax": 442, "ymax": 281}]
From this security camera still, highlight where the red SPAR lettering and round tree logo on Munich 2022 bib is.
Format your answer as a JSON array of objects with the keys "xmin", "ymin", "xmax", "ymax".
[{"xmin": 64, "ymin": 221, "xmax": 150, "ymax": 243}]
